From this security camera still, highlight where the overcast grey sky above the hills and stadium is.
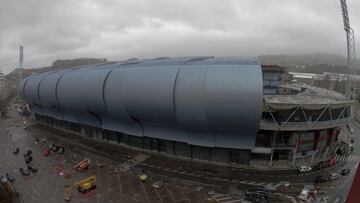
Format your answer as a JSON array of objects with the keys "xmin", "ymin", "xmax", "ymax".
[{"xmin": 0, "ymin": 0, "xmax": 360, "ymax": 73}]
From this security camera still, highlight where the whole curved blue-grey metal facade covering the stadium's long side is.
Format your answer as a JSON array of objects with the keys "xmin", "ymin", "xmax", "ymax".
[{"xmin": 19, "ymin": 57, "xmax": 263, "ymax": 149}]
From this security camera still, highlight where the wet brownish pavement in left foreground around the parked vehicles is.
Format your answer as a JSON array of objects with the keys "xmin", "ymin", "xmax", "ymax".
[{"xmin": 0, "ymin": 113, "xmax": 217, "ymax": 203}]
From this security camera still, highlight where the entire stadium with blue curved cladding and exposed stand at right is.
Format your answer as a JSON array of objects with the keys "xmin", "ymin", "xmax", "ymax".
[{"xmin": 19, "ymin": 57, "xmax": 354, "ymax": 166}]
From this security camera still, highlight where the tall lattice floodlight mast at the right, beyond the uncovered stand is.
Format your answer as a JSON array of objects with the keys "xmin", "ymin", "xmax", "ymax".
[{"xmin": 340, "ymin": 0, "xmax": 356, "ymax": 99}]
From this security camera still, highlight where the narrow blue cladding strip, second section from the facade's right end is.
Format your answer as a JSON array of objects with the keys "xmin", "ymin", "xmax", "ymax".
[{"xmin": 174, "ymin": 65, "xmax": 215, "ymax": 147}]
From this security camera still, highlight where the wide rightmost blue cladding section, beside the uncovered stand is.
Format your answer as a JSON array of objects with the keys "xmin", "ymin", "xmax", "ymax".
[{"xmin": 205, "ymin": 65, "xmax": 263, "ymax": 149}]
